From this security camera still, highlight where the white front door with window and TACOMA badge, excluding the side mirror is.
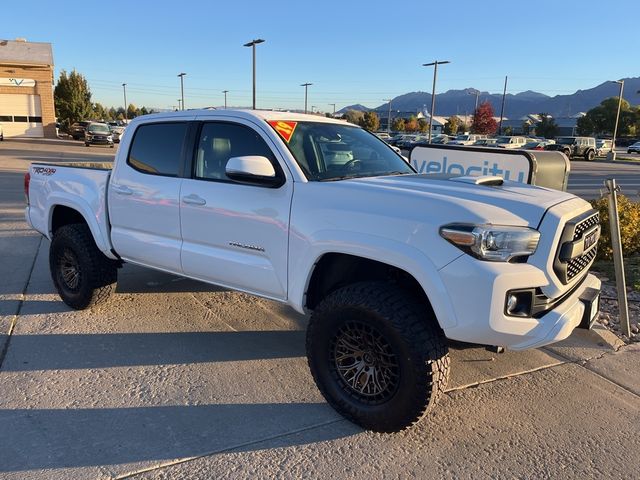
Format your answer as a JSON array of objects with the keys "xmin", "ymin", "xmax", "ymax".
[{"xmin": 180, "ymin": 120, "xmax": 293, "ymax": 299}]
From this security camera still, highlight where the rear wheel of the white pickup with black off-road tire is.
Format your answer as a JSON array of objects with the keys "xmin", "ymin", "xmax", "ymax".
[{"xmin": 49, "ymin": 224, "xmax": 118, "ymax": 310}]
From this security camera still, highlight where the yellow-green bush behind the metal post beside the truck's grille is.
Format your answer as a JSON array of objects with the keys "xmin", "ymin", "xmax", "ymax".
[{"xmin": 591, "ymin": 195, "xmax": 640, "ymax": 260}]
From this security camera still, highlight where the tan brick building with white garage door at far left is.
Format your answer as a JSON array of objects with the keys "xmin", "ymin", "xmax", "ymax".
[{"xmin": 0, "ymin": 39, "xmax": 56, "ymax": 138}]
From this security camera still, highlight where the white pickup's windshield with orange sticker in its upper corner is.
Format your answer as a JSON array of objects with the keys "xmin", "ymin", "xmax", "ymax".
[{"xmin": 269, "ymin": 121, "xmax": 415, "ymax": 181}]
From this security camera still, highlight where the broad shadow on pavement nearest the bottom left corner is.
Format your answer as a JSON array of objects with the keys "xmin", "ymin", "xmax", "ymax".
[{"xmin": 0, "ymin": 403, "xmax": 350, "ymax": 472}]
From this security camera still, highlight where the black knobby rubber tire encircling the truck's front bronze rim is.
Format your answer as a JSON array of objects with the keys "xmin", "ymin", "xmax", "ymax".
[{"xmin": 306, "ymin": 282, "xmax": 449, "ymax": 432}]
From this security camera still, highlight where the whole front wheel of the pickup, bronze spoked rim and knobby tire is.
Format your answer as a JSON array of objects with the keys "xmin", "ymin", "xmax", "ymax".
[{"xmin": 307, "ymin": 282, "xmax": 449, "ymax": 432}]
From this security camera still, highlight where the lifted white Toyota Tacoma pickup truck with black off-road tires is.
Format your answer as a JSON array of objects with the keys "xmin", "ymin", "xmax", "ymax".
[{"xmin": 25, "ymin": 110, "xmax": 600, "ymax": 432}]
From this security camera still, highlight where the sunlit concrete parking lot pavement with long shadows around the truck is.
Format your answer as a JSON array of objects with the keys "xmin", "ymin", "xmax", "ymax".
[{"xmin": 0, "ymin": 140, "xmax": 640, "ymax": 479}]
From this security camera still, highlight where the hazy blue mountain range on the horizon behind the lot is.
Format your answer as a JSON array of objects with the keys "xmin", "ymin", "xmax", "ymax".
[{"xmin": 336, "ymin": 77, "xmax": 640, "ymax": 119}]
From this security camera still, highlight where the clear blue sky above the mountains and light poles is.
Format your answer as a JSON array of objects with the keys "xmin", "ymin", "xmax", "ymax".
[{"xmin": 0, "ymin": 0, "xmax": 640, "ymax": 111}]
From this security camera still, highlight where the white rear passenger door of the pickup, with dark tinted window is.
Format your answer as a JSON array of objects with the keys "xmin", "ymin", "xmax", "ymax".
[{"xmin": 108, "ymin": 121, "xmax": 190, "ymax": 273}]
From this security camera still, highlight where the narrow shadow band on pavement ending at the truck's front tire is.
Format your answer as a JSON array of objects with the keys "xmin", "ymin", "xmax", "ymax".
[{"xmin": 2, "ymin": 330, "xmax": 305, "ymax": 372}]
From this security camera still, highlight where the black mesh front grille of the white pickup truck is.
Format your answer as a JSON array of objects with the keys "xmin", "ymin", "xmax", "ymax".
[{"xmin": 553, "ymin": 210, "xmax": 600, "ymax": 285}]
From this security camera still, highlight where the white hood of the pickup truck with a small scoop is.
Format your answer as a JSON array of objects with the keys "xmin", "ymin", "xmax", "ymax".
[{"xmin": 339, "ymin": 174, "xmax": 576, "ymax": 228}]
